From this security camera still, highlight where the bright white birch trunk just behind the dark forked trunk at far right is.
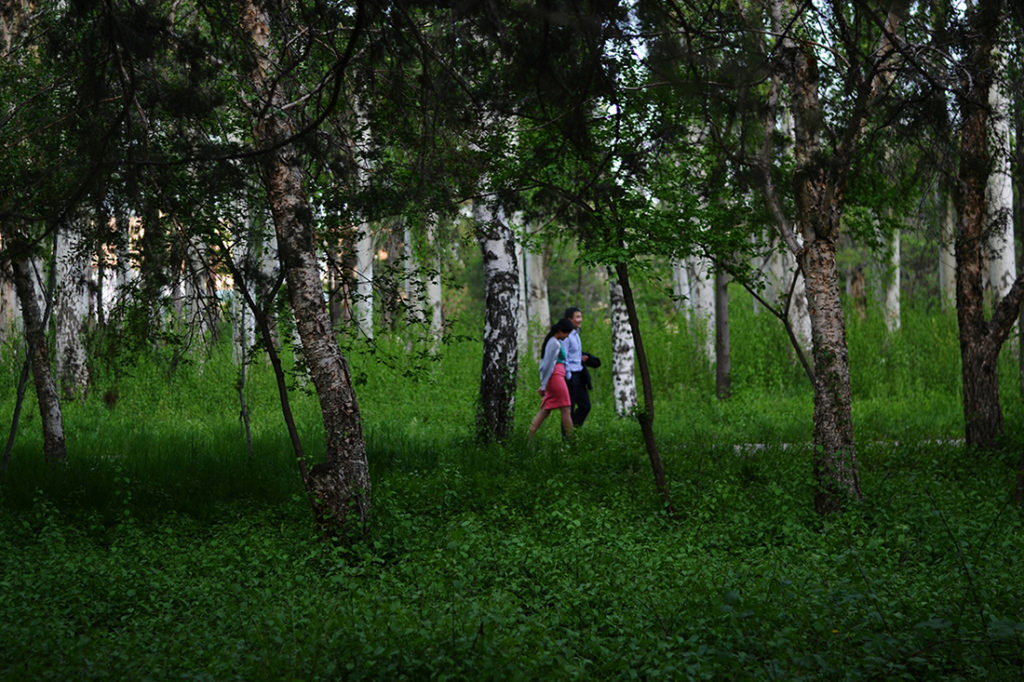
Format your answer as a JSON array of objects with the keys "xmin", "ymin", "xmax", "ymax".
[{"xmin": 985, "ymin": 70, "xmax": 1017, "ymax": 300}]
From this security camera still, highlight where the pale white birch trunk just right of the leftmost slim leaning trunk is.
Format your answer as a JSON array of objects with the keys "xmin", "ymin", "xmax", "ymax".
[{"xmin": 53, "ymin": 226, "xmax": 91, "ymax": 400}]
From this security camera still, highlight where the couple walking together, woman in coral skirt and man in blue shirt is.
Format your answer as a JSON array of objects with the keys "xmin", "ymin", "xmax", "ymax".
[{"xmin": 528, "ymin": 307, "xmax": 600, "ymax": 438}]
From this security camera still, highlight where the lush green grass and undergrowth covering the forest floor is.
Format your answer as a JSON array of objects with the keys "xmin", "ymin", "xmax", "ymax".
[{"xmin": 0, "ymin": 290, "xmax": 1024, "ymax": 680}]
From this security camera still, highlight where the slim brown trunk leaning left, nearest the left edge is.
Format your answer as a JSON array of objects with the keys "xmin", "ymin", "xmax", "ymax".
[{"xmin": 11, "ymin": 247, "xmax": 68, "ymax": 462}]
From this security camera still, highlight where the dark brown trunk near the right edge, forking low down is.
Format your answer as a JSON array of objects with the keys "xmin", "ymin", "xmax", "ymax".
[{"xmin": 953, "ymin": 3, "xmax": 1024, "ymax": 447}]
